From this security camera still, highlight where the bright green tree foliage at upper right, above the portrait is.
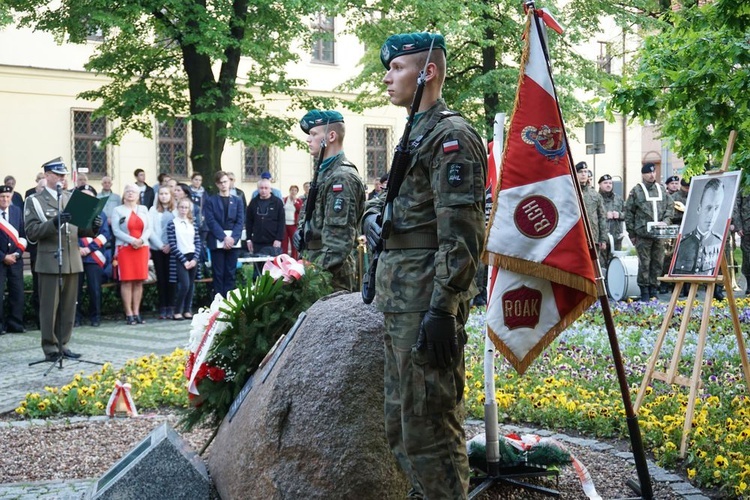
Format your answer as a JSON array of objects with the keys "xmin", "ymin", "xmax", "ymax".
[{"xmin": 607, "ymin": 0, "xmax": 750, "ymax": 179}]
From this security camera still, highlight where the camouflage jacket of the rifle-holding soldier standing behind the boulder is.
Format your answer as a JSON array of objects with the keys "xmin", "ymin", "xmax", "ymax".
[{"xmin": 299, "ymin": 152, "xmax": 365, "ymax": 291}]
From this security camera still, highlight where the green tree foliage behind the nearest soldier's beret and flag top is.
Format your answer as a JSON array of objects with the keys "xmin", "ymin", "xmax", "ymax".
[{"xmin": 344, "ymin": 0, "xmax": 659, "ymax": 138}]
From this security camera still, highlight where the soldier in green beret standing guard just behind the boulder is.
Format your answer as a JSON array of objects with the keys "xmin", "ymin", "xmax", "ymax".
[{"xmin": 295, "ymin": 110, "xmax": 365, "ymax": 292}]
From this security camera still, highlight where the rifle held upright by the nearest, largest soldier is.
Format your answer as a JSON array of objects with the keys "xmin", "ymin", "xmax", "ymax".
[{"xmin": 362, "ymin": 37, "xmax": 435, "ymax": 304}]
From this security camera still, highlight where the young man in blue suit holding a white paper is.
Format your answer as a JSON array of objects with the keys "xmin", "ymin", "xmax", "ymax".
[{"xmin": 203, "ymin": 170, "xmax": 245, "ymax": 297}]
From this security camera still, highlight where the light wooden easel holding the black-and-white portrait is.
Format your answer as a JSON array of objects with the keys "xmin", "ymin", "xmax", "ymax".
[{"xmin": 634, "ymin": 131, "xmax": 750, "ymax": 458}]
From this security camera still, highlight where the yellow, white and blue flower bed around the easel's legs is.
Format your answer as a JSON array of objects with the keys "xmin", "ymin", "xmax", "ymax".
[{"xmin": 465, "ymin": 299, "xmax": 750, "ymax": 498}]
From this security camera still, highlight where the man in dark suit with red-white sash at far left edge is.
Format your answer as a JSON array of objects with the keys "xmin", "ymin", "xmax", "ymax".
[{"xmin": 0, "ymin": 185, "xmax": 26, "ymax": 333}]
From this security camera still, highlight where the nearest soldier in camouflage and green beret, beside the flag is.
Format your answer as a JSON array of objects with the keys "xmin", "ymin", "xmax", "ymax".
[{"xmin": 363, "ymin": 33, "xmax": 487, "ymax": 500}]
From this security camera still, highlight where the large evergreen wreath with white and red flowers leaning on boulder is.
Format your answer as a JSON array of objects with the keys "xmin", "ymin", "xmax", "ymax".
[{"xmin": 182, "ymin": 254, "xmax": 332, "ymax": 429}]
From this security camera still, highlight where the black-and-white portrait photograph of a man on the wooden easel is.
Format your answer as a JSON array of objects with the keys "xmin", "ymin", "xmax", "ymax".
[{"xmin": 669, "ymin": 171, "xmax": 741, "ymax": 277}]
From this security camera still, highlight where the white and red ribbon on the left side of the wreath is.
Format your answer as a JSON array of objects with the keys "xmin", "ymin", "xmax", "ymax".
[{"xmin": 185, "ymin": 293, "xmax": 227, "ymax": 396}]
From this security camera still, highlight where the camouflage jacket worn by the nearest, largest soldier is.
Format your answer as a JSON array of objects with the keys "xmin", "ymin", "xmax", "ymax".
[{"xmin": 367, "ymin": 99, "xmax": 487, "ymax": 314}]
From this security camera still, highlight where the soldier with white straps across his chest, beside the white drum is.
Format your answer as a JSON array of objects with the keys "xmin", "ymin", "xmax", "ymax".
[{"xmin": 625, "ymin": 163, "xmax": 674, "ymax": 302}]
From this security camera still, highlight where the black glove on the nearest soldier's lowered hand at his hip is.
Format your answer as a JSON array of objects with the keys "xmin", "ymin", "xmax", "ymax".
[{"xmin": 417, "ymin": 308, "xmax": 458, "ymax": 369}]
